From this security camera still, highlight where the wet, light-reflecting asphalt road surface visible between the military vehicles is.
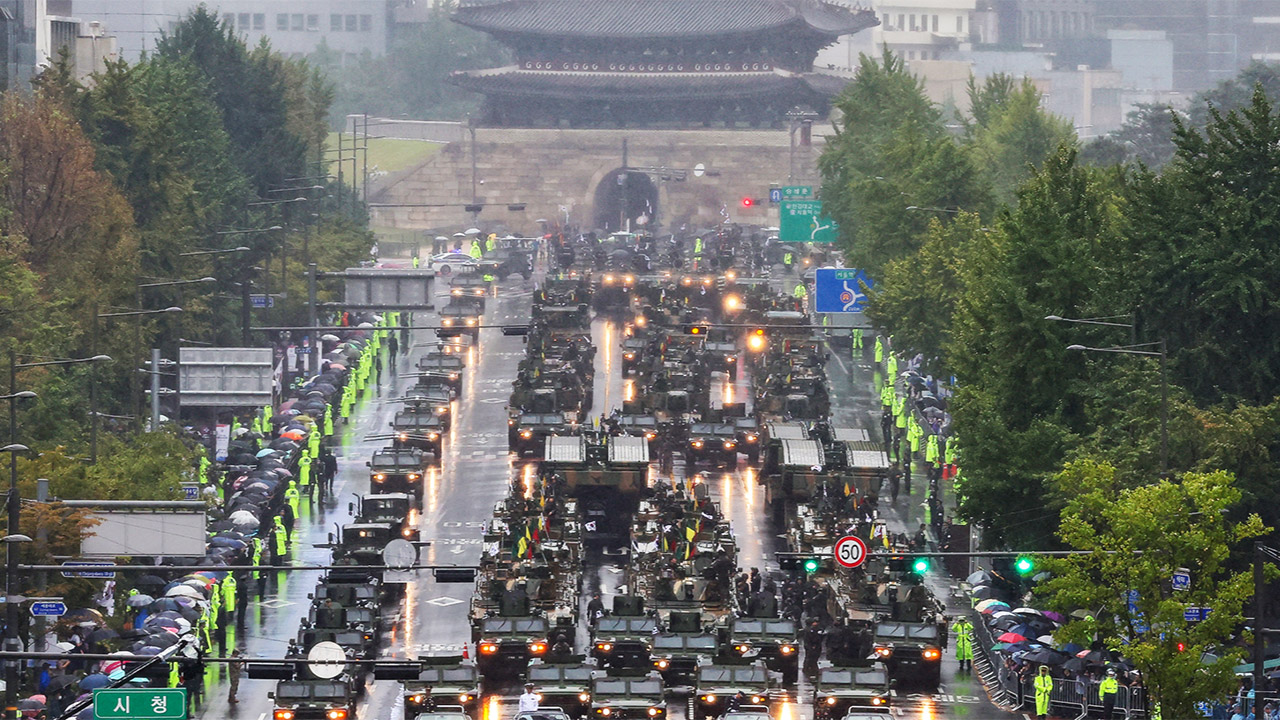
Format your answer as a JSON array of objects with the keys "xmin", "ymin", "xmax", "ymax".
[{"xmin": 196, "ymin": 266, "xmax": 1018, "ymax": 720}]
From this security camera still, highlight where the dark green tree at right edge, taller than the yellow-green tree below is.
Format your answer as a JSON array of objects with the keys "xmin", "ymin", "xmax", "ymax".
[{"xmin": 1115, "ymin": 88, "xmax": 1280, "ymax": 404}]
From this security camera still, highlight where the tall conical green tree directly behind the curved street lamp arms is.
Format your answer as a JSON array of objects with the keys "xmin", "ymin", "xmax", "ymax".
[{"xmin": 947, "ymin": 147, "xmax": 1121, "ymax": 547}]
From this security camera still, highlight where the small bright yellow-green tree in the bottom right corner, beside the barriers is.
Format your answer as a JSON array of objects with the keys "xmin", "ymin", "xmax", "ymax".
[{"xmin": 1036, "ymin": 460, "xmax": 1267, "ymax": 717}]
